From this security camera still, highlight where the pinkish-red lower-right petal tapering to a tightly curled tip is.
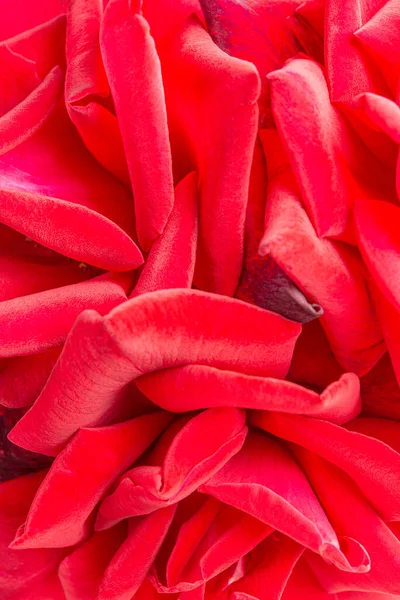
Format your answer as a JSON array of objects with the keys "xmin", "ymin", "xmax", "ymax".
[{"xmin": 200, "ymin": 433, "xmax": 369, "ymax": 573}]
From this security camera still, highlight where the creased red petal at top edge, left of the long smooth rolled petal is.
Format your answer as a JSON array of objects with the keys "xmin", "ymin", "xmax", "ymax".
[{"xmin": 65, "ymin": 0, "xmax": 129, "ymax": 183}]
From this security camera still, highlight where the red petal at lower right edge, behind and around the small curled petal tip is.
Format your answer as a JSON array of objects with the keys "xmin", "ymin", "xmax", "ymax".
[{"xmin": 294, "ymin": 447, "xmax": 400, "ymax": 594}]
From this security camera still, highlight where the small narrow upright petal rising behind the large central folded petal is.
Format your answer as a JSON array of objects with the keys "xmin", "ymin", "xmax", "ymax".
[{"xmin": 130, "ymin": 173, "xmax": 197, "ymax": 298}]
